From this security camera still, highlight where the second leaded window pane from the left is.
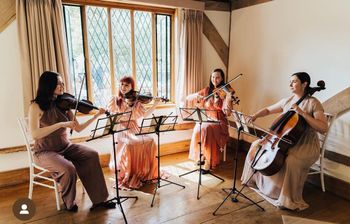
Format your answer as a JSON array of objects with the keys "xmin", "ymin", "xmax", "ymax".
[{"xmin": 87, "ymin": 6, "xmax": 112, "ymax": 106}]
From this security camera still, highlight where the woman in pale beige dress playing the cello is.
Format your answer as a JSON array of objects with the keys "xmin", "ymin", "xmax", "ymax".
[{"xmin": 241, "ymin": 72, "xmax": 327, "ymax": 210}]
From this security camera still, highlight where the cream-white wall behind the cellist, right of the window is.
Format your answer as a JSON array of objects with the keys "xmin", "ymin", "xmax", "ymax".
[{"xmin": 229, "ymin": 0, "xmax": 350, "ymax": 182}]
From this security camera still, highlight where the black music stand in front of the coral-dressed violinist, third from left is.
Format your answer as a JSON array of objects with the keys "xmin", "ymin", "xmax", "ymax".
[{"xmin": 179, "ymin": 107, "xmax": 225, "ymax": 199}]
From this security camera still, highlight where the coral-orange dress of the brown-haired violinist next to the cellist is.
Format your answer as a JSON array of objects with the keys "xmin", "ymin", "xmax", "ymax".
[{"xmin": 189, "ymin": 87, "xmax": 229, "ymax": 168}]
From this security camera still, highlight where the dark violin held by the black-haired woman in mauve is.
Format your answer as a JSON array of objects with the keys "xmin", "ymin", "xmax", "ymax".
[{"xmin": 56, "ymin": 93, "xmax": 108, "ymax": 115}]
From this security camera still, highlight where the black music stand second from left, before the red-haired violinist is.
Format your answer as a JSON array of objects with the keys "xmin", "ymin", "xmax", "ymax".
[{"xmin": 137, "ymin": 115, "xmax": 185, "ymax": 207}]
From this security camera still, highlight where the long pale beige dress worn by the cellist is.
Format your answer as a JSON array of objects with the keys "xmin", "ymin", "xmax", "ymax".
[{"xmin": 241, "ymin": 97, "xmax": 323, "ymax": 210}]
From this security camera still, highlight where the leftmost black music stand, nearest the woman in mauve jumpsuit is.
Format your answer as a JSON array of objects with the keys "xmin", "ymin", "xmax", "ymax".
[{"xmin": 87, "ymin": 111, "xmax": 138, "ymax": 223}]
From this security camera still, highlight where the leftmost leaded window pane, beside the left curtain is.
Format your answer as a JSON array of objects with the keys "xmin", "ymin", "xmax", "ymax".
[{"xmin": 63, "ymin": 5, "xmax": 87, "ymax": 99}]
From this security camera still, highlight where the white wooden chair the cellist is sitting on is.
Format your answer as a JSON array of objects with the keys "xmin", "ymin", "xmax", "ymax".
[{"xmin": 309, "ymin": 113, "xmax": 336, "ymax": 192}]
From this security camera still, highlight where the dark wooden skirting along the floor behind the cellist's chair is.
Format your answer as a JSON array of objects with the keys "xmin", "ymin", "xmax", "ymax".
[{"xmin": 307, "ymin": 174, "xmax": 350, "ymax": 200}]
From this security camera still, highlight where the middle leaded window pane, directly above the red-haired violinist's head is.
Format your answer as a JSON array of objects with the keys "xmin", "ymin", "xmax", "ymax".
[{"xmin": 111, "ymin": 9, "xmax": 132, "ymax": 83}]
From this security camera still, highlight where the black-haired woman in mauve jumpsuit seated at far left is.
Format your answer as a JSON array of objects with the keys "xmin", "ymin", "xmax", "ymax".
[{"xmin": 29, "ymin": 71, "xmax": 115, "ymax": 212}]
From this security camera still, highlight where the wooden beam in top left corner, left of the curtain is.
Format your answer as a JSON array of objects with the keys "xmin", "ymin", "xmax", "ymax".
[{"xmin": 0, "ymin": 0, "xmax": 16, "ymax": 33}]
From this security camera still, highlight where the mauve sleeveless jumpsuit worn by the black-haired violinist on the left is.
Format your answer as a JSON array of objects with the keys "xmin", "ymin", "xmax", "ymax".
[{"xmin": 34, "ymin": 105, "xmax": 108, "ymax": 209}]
